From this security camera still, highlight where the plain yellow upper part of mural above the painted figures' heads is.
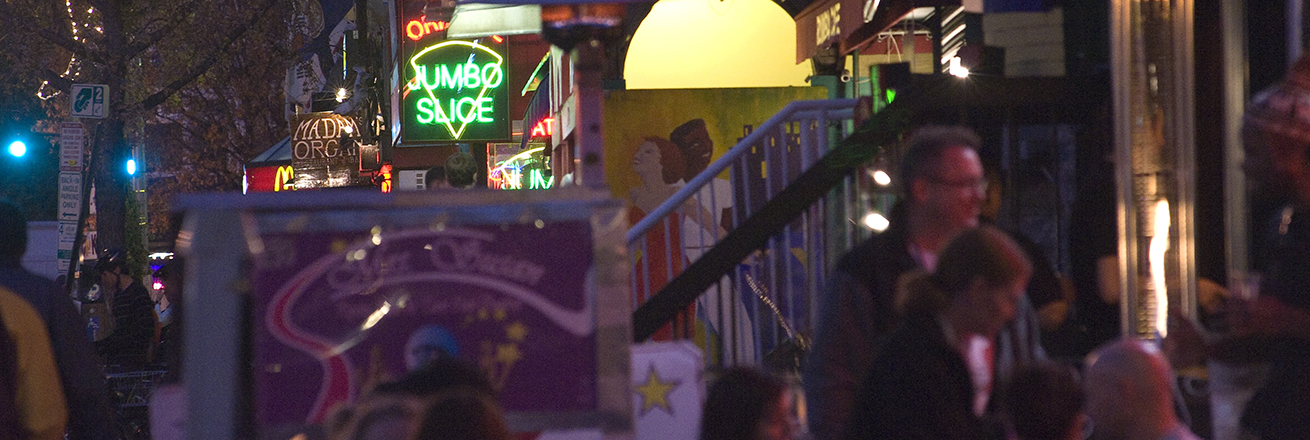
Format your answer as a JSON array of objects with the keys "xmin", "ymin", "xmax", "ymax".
[{"xmin": 604, "ymin": 86, "xmax": 828, "ymax": 201}]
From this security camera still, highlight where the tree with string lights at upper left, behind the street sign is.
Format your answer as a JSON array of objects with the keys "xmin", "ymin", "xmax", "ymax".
[{"xmin": 0, "ymin": 0, "xmax": 292, "ymax": 248}]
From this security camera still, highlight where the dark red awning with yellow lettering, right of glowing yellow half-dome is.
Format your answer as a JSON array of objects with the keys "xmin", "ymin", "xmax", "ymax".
[{"xmin": 795, "ymin": 0, "xmax": 960, "ymax": 64}]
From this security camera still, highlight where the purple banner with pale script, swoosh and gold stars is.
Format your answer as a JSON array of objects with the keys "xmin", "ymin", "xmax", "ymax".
[{"xmin": 252, "ymin": 221, "xmax": 596, "ymax": 427}]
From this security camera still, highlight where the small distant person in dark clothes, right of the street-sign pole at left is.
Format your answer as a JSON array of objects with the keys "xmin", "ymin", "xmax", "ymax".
[{"xmin": 96, "ymin": 250, "xmax": 157, "ymax": 369}]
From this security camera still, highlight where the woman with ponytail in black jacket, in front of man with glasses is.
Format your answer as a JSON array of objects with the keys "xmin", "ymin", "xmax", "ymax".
[{"xmin": 846, "ymin": 225, "xmax": 1032, "ymax": 440}]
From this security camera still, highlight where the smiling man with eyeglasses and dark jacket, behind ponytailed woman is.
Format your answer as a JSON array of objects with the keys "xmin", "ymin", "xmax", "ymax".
[{"xmin": 803, "ymin": 126, "xmax": 1045, "ymax": 440}]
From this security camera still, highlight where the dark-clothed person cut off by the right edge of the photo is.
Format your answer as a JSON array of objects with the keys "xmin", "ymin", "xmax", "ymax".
[{"xmin": 1216, "ymin": 50, "xmax": 1310, "ymax": 439}]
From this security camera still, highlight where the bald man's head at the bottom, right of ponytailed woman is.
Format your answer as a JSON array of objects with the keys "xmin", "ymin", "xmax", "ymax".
[{"xmin": 1083, "ymin": 338, "xmax": 1178, "ymax": 437}]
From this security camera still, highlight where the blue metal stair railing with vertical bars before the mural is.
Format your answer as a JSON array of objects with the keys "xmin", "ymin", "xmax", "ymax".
[{"xmin": 626, "ymin": 100, "xmax": 895, "ymax": 364}]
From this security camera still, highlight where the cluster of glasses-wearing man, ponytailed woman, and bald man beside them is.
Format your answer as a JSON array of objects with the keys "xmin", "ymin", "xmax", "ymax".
[{"xmin": 785, "ymin": 121, "xmax": 1195, "ymax": 440}]
